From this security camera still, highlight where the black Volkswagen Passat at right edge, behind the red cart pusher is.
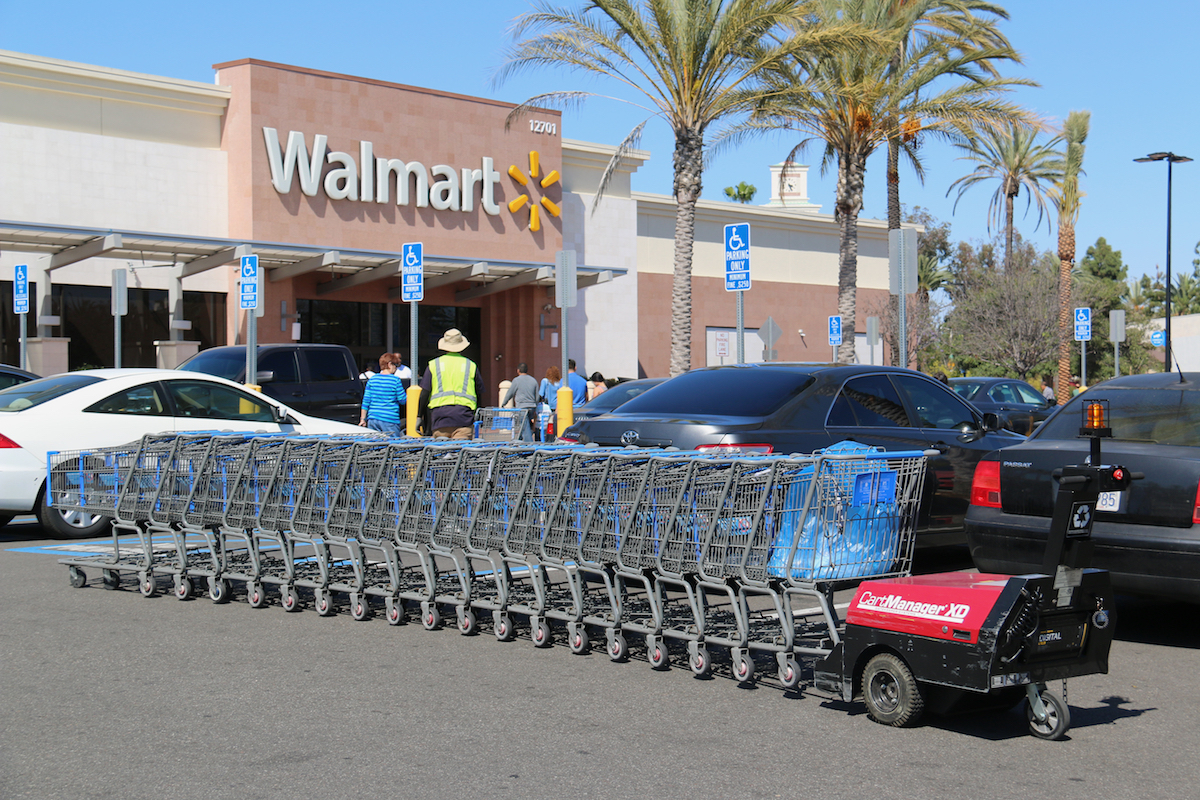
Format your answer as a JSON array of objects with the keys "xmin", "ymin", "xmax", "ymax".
[{"xmin": 966, "ymin": 372, "xmax": 1200, "ymax": 602}]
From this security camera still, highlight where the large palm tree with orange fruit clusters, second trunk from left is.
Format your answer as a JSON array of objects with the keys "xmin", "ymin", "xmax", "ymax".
[{"xmin": 734, "ymin": 0, "xmax": 1026, "ymax": 363}]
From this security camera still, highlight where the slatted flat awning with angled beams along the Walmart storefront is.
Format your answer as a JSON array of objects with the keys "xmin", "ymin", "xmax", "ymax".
[{"xmin": 0, "ymin": 221, "xmax": 626, "ymax": 301}]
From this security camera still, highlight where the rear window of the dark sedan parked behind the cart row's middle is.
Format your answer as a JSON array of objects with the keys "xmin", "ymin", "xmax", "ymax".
[{"xmin": 601, "ymin": 368, "xmax": 812, "ymax": 416}]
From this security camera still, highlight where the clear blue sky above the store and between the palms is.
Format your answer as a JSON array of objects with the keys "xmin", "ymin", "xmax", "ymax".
[{"xmin": 0, "ymin": 0, "xmax": 1200, "ymax": 284}]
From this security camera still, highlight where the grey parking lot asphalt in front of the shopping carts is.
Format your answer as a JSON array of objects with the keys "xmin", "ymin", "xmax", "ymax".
[{"xmin": 0, "ymin": 518, "xmax": 1200, "ymax": 800}]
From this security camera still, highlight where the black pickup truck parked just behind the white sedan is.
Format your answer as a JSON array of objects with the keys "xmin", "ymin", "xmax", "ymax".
[{"xmin": 179, "ymin": 344, "xmax": 362, "ymax": 425}]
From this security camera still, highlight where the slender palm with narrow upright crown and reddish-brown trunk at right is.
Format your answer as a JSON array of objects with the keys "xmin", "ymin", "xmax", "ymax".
[{"xmin": 1051, "ymin": 112, "xmax": 1092, "ymax": 405}]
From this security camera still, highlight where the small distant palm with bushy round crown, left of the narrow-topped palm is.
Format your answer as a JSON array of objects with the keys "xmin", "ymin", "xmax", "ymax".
[{"xmin": 946, "ymin": 122, "xmax": 1062, "ymax": 269}]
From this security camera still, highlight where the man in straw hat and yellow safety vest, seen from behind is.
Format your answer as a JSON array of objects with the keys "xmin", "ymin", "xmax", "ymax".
[{"xmin": 421, "ymin": 327, "xmax": 484, "ymax": 439}]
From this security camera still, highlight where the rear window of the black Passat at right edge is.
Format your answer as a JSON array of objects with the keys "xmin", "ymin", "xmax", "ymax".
[{"xmin": 1034, "ymin": 386, "xmax": 1200, "ymax": 447}]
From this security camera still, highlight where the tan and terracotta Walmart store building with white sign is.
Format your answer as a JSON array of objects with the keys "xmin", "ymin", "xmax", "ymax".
[{"xmin": 0, "ymin": 50, "xmax": 902, "ymax": 402}]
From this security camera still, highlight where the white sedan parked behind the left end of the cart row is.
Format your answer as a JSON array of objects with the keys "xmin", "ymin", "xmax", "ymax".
[{"xmin": 0, "ymin": 369, "xmax": 362, "ymax": 539}]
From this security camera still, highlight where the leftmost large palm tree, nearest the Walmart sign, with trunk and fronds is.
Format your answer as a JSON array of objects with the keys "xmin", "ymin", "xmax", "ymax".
[{"xmin": 497, "ymin": 0, "xmax": 858, "ymax": 375}]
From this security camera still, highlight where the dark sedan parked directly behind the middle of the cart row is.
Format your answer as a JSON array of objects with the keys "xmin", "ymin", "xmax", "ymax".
[{"xmin": 563, "ymin": 363, "xmax": 1024, "ymax": 546}]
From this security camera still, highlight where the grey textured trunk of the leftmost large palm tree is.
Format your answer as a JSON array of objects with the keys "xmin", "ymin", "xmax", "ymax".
[{"xmin": 671, "ymin": 130, "xmax": 704, "ymax": 378}]
